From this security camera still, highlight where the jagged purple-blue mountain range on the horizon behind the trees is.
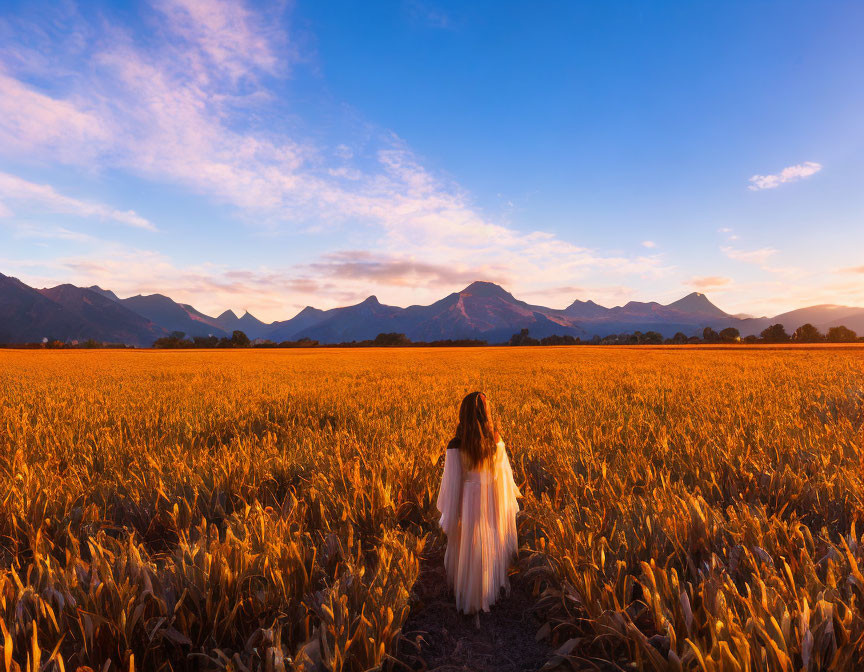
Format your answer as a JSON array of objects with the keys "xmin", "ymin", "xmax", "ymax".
[{"xmin": 0, "ymin": 274, "xmax": 864, "ymax": 347}]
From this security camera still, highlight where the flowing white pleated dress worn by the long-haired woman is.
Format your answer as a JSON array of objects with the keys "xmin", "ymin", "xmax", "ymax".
[{"xmin": 437, "ymin": 441, "xmax": 521, "ymax": 614}]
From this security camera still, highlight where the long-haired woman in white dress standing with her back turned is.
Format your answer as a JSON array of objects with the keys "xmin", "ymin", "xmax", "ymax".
[{"xmin": 438, "ymin": 392, "xmax": 521, "ymax": 614}]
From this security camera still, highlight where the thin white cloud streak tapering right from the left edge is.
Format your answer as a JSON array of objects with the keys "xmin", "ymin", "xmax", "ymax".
[{"xmin": 0, "ymin": 173, "xmax": 156, "ymax": 231}]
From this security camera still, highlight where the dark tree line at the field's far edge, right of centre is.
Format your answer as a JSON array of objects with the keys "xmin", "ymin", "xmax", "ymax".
[{"xmin": 508, "ymin": 324, "xmax": 864, "ymax": 345}]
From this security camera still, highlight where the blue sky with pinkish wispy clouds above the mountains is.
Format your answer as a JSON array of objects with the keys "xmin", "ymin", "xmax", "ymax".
[{"xmin": 0, "ymin": 0, "xmax": 864, "ymax": 319}]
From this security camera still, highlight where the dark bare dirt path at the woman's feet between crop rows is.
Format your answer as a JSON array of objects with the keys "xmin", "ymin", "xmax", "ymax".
[{"xmin": 398, "ymin": 538, "xmax": 551, "ymax": 672}]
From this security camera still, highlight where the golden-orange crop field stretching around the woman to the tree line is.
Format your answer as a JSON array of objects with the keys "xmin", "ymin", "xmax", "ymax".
[{"xmin": 0, "ymin": 347, "xmax": 864, "ymax": 672}]
